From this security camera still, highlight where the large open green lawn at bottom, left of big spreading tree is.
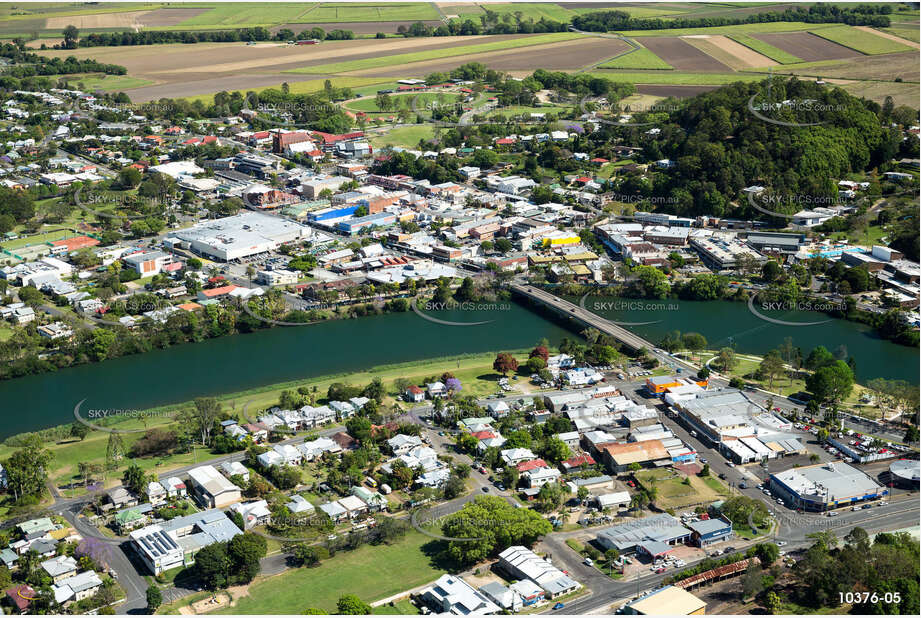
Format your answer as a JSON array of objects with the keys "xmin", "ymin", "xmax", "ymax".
[{"xmin": 217, "ymin": 531, "xmax": 445, "ymax": 615}]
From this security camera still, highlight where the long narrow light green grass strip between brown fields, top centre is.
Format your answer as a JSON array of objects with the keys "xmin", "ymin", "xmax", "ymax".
[{"xmin": 285, "ymin": 32, "xmax": 583, "ymax": 74}]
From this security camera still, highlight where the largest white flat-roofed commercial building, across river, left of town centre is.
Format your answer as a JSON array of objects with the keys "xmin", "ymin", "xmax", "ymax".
[{"xmin": 171, "ymin": 212, "xmax": 313, "ymax": 262}]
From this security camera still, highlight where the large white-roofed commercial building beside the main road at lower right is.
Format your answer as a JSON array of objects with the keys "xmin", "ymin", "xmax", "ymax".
[{"xmin": 769, "ymin": 462, "xmax": 889, "ymax": 511}]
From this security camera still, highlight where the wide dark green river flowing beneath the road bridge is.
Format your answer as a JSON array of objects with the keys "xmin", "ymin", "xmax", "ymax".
[{"xmin": 0, "ymin": 297, "xmax": 918, "ymax": 438}]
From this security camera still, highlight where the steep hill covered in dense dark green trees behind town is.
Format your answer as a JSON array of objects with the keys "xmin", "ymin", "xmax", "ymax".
[{"xmin": 613, "ymin": 78, "xmax": 904, "ymax": 216}]
